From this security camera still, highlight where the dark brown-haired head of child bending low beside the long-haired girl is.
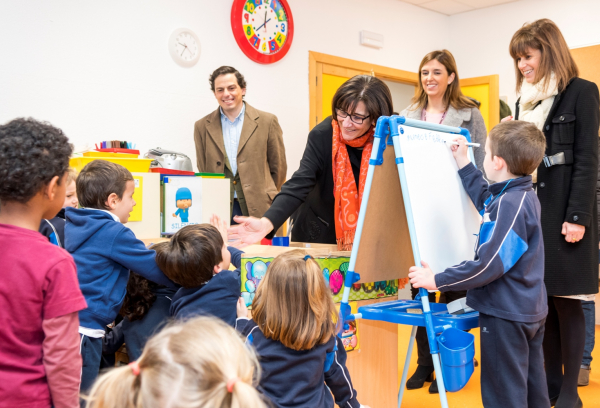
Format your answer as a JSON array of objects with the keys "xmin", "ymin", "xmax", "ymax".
[{"xmin": 152, "ymin": 224, "xmax": 231, "ymax": 288}]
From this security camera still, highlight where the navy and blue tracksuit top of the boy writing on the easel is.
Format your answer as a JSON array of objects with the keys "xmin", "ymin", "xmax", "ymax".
[{"xmin": 435, "ymin": 164, "xmax": 548, "ymax": 323}]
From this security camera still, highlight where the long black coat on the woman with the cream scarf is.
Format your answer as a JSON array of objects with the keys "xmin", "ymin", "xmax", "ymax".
[{"xmin": 515, "ymin": 78, "xmax": 600, "ymax": 296}]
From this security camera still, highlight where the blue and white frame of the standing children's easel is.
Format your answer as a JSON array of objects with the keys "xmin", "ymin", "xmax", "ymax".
[{"xmin": 340, "ymin": 115, "xmax": 477, "ymax": 408}]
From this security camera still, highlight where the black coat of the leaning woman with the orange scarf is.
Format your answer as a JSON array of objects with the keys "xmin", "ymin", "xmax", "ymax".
[{"xmin": 264, "ymin": 117, "xmax": 362, "ymax": 244}]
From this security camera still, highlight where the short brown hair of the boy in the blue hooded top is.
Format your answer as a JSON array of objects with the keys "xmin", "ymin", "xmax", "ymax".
[{"xmin": 75, "ymin": 160, "xmax": 133, "ymax": 210}]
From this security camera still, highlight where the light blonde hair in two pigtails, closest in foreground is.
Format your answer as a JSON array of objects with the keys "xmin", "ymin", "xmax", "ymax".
[{"xmin": 86, "ymin": 317, "xmax": 266, "ymax": 408}]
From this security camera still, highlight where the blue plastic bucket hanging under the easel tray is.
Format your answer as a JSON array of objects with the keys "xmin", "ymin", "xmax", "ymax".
[{"xmin": 437, "ymin": 328, "xmax": 475, "ymax": 392}]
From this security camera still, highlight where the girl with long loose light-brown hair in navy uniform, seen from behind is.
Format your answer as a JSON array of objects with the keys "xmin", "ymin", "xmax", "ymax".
[{"xmin": 236, "ymin": 250, "xmax": 368, "ymax": 408}]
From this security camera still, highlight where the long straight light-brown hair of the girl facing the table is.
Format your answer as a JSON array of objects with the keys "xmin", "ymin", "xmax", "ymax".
[{"xmin": 252, "ymin": 250, "xmax": 337, "ymax": 350}]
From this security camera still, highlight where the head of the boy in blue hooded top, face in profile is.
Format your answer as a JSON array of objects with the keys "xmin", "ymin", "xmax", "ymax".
[{"xmin": 76, "ymin": 160, "xmax": 135, "ymax": 224}]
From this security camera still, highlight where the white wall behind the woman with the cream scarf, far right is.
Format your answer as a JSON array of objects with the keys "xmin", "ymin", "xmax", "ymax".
[{"xmin": 449, "ymin": 0, "xmax": 600, "ymax": 113}]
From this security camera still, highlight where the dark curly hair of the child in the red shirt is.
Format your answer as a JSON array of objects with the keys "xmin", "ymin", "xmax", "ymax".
[{"xmin": 0, "ymin": 118, "xmax": 73, "ymax": 204}]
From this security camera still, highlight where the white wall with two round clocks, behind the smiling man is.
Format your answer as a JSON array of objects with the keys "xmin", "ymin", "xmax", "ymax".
[{"xmin": 0, "ymin": 0, "xmax": 450, "ymax": 175}]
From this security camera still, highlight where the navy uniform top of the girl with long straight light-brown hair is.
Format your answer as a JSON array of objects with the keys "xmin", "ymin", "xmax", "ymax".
[{"xmin": 236, "ymin": 318, "xmax": 361, "ymax": 408}]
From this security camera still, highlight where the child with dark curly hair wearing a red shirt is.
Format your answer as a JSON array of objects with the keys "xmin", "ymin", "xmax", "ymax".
[{"xmin": 0, "ymin": 119, "xmax": 86, "ymax": 408}]
